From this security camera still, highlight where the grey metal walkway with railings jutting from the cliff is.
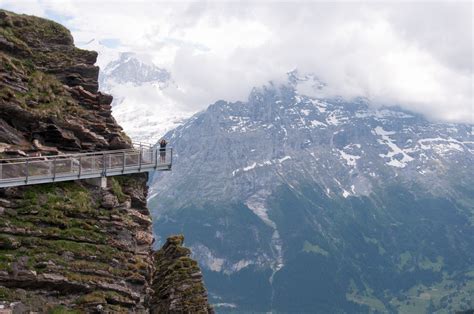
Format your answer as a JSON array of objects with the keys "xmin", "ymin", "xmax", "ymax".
[{"xmin": 0, "ymin": 144, "xmax": 173, "ymax": 188}]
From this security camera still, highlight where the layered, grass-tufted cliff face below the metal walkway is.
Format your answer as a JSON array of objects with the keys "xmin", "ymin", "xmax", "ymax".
[{"xmin": 0, "ymin": 176, "xmax": 153, "ymax": 312}]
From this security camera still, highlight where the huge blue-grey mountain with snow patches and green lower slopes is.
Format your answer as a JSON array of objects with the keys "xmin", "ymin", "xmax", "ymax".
[{"xmin": 150, "ymin": 76, "xmax": 474, "ymax": 313}]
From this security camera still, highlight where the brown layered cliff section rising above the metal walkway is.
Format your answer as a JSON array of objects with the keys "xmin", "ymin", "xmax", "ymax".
[{"xmin": 0, "ymin": 11, "xmax": 131, "ymax": 154}]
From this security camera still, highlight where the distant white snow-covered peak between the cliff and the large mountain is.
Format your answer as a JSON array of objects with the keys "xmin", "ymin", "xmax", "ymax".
[{"xmin": 99, "ymin": 52, "xmax": 194, "ymax": 143}]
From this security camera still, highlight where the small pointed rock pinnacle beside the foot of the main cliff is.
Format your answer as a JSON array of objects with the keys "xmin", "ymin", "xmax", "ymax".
[{"xmin": 150, "ymin": 235, "xmax": 213, "ymax": 313}]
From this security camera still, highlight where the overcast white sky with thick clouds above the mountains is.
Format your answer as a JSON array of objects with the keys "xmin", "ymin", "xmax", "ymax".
[{"xmin": 0, "ymin": 0, "xmax": 474, "ymax": 123}]
